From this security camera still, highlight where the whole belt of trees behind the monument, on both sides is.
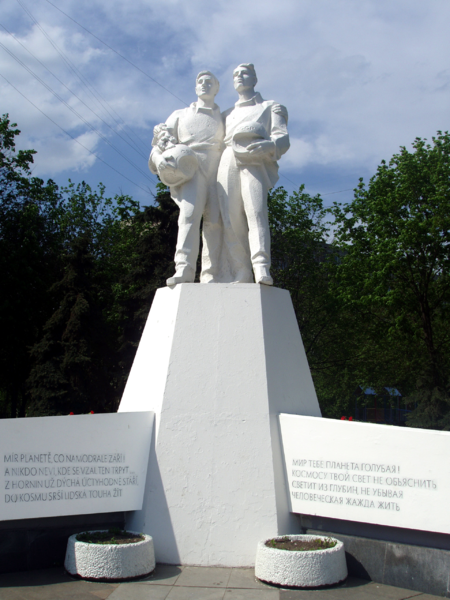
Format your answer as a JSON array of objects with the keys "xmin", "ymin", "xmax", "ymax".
[{"xmin": 0, "ymin": 115, "xmax": 450, "ymax": 429}]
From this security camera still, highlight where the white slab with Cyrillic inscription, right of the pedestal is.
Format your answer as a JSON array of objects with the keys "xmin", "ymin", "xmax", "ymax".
[{"xmin": 280, "ymin": 414, "xmax": 450, "ymax": 533}]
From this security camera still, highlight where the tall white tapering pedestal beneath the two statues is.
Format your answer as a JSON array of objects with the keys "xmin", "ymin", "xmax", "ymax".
[{"xmin": 119, "ymin": 284, "xmax": 320, "ymax": 566}]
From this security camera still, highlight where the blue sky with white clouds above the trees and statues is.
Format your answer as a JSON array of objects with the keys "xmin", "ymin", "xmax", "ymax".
[{"xmin": 0, "ymin": 0, "xmax": 450, "ymax": 205}]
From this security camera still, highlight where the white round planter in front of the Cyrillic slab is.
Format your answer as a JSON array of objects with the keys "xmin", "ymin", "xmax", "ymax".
[{"xmin": 255, "ymin": 535, "xmax": 348, "ymax": 588}]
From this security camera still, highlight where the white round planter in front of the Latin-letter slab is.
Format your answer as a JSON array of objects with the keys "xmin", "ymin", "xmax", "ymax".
[{"xmin": 64, "ymin": 532, "xmax": 155, "ymax": 581}]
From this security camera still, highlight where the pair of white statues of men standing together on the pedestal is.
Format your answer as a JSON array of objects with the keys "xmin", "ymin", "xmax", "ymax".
[{"xmin": 149, "ymin": 64, "xmax": 289, "ymax": 285}]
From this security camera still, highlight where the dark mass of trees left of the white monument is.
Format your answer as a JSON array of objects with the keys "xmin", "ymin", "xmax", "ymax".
[{"xmin": 0, "ymin": 115, "xmax": 177, "ymax": 417}]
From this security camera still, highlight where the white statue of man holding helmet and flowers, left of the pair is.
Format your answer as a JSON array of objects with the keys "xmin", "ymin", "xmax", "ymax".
[{"xmin": 149, "ymin": 71, "xmax": 224, "ymax": 285}]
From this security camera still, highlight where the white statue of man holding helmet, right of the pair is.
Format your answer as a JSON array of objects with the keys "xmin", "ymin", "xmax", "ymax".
[{"xmin": 218, "ymin": 64, "xmax": 289, "ymax": 285}]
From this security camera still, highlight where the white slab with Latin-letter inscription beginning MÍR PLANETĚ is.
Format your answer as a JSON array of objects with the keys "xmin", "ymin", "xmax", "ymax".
[{"xmin": 0, "ymin": 412, "xmax": 154, "ymax": 521}]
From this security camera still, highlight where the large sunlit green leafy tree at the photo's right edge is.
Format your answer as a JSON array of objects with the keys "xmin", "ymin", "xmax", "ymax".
[{"xmin": 333, "ymin": 132, "xmax": 450, "ymax": 429}]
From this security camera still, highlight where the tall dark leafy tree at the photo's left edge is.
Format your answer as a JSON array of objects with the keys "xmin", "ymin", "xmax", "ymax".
[{"xmin": 0, "ymin": 115, "xmax": 61, "ymax": 417}]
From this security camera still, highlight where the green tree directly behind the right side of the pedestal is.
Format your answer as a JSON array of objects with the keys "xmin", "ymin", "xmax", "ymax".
[{"xmin": 269, "ymin": 186, "xmax": 357, "ymax": 417}]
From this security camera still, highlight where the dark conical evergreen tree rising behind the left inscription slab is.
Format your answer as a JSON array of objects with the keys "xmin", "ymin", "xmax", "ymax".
[{"xmin": 28, "ymin": 233, "xmax": 115, "ymax": 415}]
